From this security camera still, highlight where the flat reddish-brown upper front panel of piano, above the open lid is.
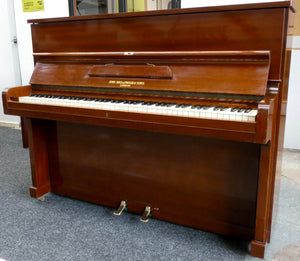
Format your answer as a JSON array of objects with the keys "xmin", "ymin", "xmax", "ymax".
[{"xmin": 32, "ymin": 8, "xmax": 284, "ymax": 79}]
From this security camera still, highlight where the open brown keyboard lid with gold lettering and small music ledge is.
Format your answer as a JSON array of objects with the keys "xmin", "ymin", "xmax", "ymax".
[{"xmin": 30, "ymin": 51, "xmax": 270, "ymax": 96}]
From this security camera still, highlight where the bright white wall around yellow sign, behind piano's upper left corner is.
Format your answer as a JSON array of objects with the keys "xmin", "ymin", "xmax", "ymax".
[{"xmin": 13, "ymin": 0, "xmax": 69, "ymax": 85}]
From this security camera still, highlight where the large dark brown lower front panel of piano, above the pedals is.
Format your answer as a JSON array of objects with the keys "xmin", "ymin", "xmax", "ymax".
[{"xmin": 49, "ymin": 122, "xmax": 260, "ymax": 239}]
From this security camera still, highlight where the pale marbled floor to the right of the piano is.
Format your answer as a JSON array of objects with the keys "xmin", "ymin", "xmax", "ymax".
[{"xmin": 260, "ymin": 150, "xmax": 300, "ymax": 261}]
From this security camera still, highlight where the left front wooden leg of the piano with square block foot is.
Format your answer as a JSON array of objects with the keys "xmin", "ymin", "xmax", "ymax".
[{"xmin": 25, "ymin": 118, "xmax": 50, "ymax": 198}]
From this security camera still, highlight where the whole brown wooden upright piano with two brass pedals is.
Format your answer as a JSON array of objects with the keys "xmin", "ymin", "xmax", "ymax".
[{"xmin": 2, "ymin": 1, "xmax": 294, "ymax": 257}]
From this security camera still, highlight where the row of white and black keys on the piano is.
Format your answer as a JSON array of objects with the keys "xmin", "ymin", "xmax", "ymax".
[{"xmin": 19, "ymin": 94, "xmax": 257, "ymax": 122}]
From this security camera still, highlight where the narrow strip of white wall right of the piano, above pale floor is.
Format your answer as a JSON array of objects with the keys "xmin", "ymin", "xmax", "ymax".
[{"xmin": 284, "ymin": 49, "xmax": 300, "ymax": 149}]
